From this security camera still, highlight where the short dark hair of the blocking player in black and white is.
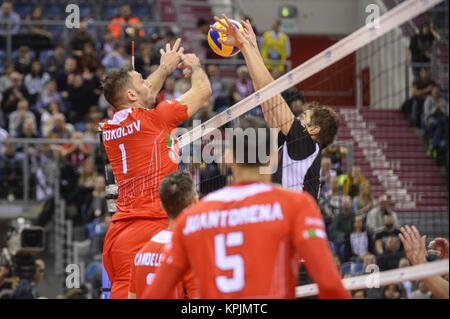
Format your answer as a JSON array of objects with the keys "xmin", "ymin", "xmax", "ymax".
[{"xmin": 305, "ymin": 102, "xmax": 339, "ymax": 149}]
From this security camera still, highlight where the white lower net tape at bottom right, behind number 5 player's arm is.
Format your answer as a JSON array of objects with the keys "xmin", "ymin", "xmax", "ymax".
[{"xmin": 295, "ymin": 259, "xmax": 449, "ymax": 298}]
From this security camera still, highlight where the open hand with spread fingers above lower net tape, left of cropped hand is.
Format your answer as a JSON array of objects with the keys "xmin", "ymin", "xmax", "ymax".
[{"xmin": 398, "ymin": 225, "xmax": 427, "ymax": 265}]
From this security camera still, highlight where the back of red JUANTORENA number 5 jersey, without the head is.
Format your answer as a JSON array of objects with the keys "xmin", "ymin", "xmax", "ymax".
[{"xmin": 173, "ymin": 183, "xmax": 325, "ymax": 298}]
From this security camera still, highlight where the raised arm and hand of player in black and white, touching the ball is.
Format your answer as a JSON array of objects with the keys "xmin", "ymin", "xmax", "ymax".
[{"xmin": 211, "ymin": 14, "xmax": 295, "ymax": 135}]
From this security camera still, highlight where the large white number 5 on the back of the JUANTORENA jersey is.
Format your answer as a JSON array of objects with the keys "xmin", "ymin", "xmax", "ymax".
[{"xmin": 214, "ymin": 232, "xmax": 245, "ymax": 293}]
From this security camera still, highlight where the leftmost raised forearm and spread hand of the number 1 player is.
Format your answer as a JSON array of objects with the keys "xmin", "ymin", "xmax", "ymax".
[{"xmin": 147, "ymin": 39, "xmax": 184, "ymax": 95}]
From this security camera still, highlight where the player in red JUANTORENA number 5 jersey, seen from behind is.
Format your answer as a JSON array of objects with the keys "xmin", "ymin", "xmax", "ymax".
[{"xmin": 143, "ymin": 118, "xmax": 350, "ymax": 298}]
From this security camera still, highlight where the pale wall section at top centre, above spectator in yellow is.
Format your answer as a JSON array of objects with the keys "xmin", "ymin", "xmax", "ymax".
[{"xmin": 236, "ymin": 0, "xmax": 359, "ymax": 35}]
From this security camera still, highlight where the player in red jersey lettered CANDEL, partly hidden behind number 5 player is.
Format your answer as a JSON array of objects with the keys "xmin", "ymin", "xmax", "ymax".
[{"xmin": 128, "ymin": 171, "xmax": 198, "ymax": 299}]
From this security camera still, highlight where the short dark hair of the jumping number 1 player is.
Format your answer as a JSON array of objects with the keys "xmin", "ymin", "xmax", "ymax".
[{"xmin": 103, "ymin": 66, "xmax": 133, "ymax": 107}]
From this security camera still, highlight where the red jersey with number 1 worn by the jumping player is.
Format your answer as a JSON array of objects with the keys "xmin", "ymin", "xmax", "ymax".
[{"xmin": 102, "ymin": 99, "xmax": 188, "ymax": 220}]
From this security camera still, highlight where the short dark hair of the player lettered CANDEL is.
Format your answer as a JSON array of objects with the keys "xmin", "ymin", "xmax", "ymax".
[{"xmin": 159, "ymin": 171, "xmax": 197, "ymax": 218}]
